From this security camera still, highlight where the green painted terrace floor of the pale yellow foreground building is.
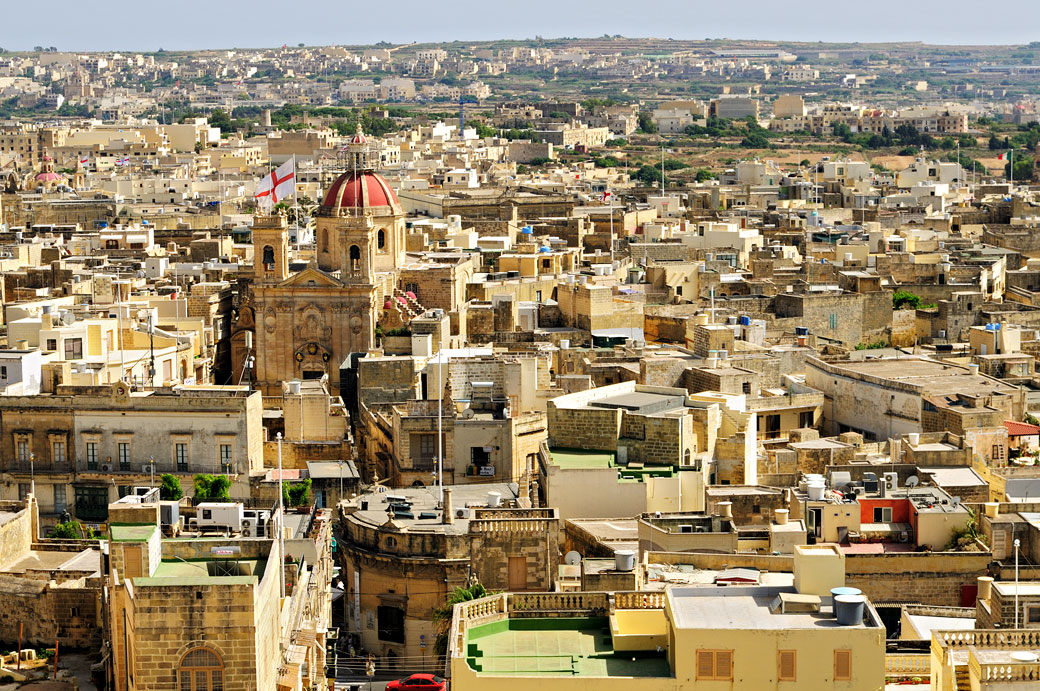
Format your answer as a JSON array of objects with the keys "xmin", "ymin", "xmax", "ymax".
[{"xmin": 466, "ymin": 617, "xmax": 672, "ymax": 677}]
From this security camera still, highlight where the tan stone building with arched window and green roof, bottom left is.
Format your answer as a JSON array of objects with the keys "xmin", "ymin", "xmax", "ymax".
[{"xmin": 105, "ymin": 490, "xmax": 332, "ymax": 691}]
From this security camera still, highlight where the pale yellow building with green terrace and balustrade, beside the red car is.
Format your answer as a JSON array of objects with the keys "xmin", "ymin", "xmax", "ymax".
[{"xmin": 448, "ymin": 545, "xmax": 885, "ymax": 691}]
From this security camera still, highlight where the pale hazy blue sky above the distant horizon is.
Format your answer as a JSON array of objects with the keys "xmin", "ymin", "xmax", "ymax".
[{"xmin": 6, "ymin": 0, "xmax": 1040, "ymax": 50}]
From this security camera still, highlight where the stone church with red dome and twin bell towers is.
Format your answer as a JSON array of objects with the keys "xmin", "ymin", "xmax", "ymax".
[{"xmin": 246, "ymin": 127, "xmax": 406, "ymax": 395}]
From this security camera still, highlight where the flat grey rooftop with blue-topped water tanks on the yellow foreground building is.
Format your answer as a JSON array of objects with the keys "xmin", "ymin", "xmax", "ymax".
[{"xmin": 665, "ymin": 586, "xmax": 883, "ymax": 631}]
